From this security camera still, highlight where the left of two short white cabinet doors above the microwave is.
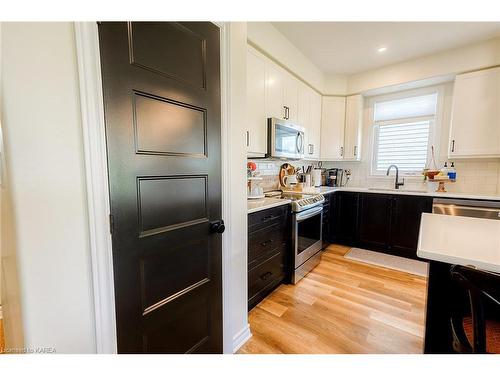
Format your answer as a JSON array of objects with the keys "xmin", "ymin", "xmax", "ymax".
[{"xmin": 266, "ymin": 60, "xmax": 287, "ymax": 119}]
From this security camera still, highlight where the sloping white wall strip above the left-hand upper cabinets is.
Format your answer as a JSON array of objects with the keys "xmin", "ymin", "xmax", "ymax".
[{"xmin": 247, "ymin": 22, "xmax": 325, "ymax": 93}]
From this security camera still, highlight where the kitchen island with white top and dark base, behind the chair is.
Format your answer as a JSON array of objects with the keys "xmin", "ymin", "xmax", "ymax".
[{"xmin": 417, "ymin": 213, "xmax": 500, "ymax": 354}]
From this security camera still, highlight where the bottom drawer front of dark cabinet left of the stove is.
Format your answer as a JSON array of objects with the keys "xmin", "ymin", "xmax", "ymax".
[{"xmin": 248, "ymin": 251, "xmax": 285, "ymax": 300}]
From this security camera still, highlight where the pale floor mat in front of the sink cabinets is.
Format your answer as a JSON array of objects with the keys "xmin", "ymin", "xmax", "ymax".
[{"xmin": 344, "ymin": 247, "xmax": 429, "ymax": 277}]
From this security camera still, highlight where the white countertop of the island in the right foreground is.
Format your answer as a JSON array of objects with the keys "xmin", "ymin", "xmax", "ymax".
[{"xmin": 417, "ymin": 213, "xmax": 500, "ymax": 272}]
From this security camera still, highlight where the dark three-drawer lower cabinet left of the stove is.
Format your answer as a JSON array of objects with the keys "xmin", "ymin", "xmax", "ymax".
[{"xmin": 248, "ymin": 205, "xmax": 291, "ymax": 310}]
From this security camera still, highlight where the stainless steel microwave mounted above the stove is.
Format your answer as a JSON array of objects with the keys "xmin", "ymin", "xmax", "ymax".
[{"xmin": 266, "ymin": 118, "xmax": 304, "ymax": 159}]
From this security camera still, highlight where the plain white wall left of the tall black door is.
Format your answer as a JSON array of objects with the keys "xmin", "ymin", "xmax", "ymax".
[{"xmin": 1, "ymin": 23, "xmax": 96, "ymax": 353}]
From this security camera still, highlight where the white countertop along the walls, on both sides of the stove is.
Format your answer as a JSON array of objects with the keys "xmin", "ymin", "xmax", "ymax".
[{"xmin": 248, "ymin": 186, "xmax": 500, "ymax": 213}]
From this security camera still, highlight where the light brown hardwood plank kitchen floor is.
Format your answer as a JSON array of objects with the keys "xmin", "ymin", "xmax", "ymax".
[{"xmin": 238, "ymin": 245, "xmax": 427, "ymax": 354}]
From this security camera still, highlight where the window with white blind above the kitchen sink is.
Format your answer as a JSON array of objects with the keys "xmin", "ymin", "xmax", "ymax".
[{"xmin": 372, "ymin": 92, "xmax": 438, "ymax": 175}]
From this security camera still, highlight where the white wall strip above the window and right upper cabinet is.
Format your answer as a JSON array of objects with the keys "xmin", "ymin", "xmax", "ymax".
[{"xmin": 347, "ymin": 38, "xmax": 500, "ymax": 94}]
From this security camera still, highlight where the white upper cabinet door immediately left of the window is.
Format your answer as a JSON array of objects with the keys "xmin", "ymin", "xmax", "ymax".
[{"xmin": 344, "ymin": 95, "xmax": 363, "ymax": 160}]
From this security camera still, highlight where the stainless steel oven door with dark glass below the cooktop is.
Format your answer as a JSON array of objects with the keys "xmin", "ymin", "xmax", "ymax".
[{"xmin": 293, "ymin": 206, "xmax": 323, "ymax": 268}]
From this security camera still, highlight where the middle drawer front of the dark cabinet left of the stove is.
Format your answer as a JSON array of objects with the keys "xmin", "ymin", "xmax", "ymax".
[{"xmin": 248, "ymin": 223, "xmax": 287, "ymax": 269}]
